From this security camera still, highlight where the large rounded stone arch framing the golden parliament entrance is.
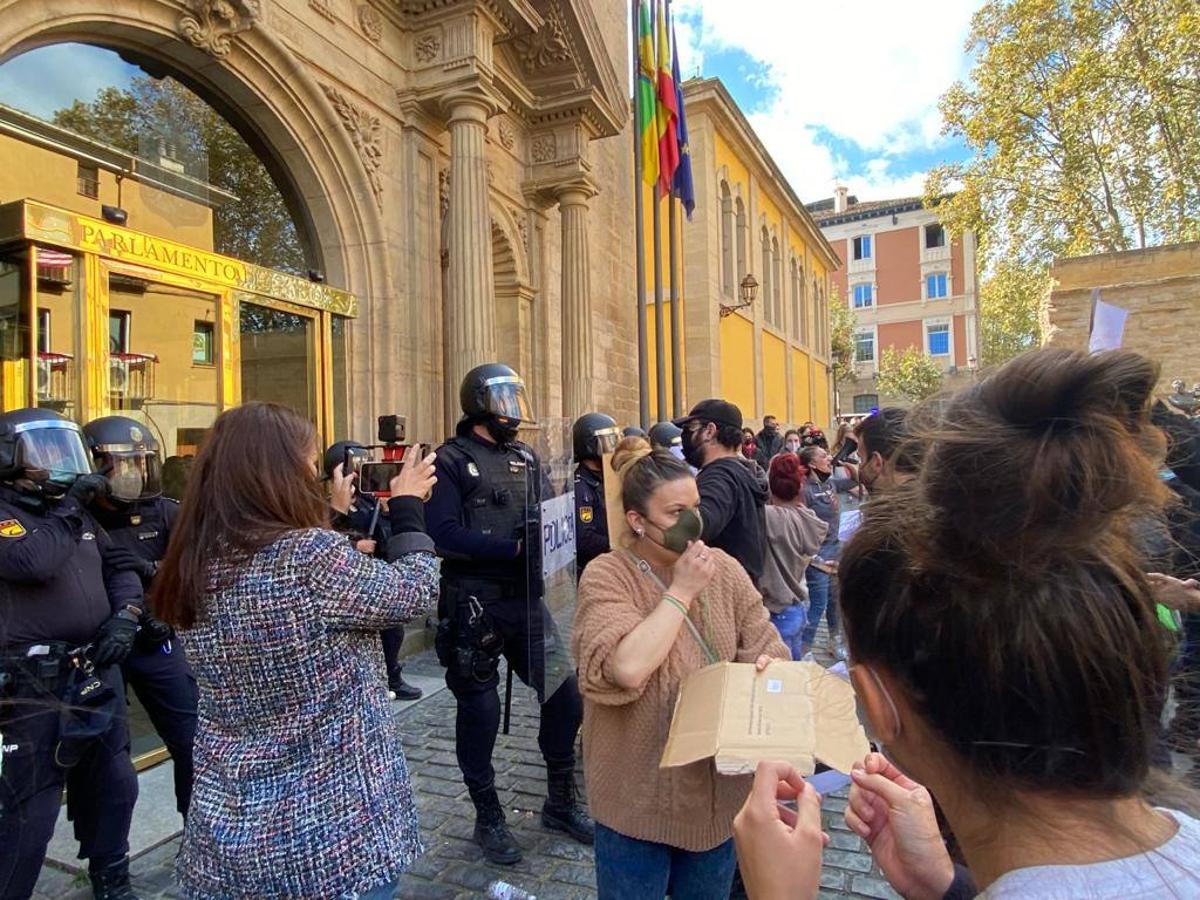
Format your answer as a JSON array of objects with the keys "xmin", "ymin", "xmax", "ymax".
[{"xmin": 0, "ymin": 0, "xmax": 400, "ymax": 433}]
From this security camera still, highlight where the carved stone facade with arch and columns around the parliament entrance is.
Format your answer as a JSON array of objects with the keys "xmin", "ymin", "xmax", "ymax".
[{"xmin": 0, "ymin": 0, "xmax": 637, "ymax": 440}]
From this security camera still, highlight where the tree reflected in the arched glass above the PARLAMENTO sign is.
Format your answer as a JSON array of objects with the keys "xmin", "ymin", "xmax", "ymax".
[{"xmin": 53, "ymin": 77, "xmax": 307, "ymax": 274}]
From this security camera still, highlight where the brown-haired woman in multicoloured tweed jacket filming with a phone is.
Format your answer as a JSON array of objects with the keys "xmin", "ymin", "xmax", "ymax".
[{"xmin": 155, "ymin": 403, "xmax": 438, "ymax": 900}]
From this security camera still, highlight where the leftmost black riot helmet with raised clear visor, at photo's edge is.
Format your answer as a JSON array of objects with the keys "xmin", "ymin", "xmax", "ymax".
[{"xmin": 0, "ymin": 408, "xmax": 91, "ymax": 497}]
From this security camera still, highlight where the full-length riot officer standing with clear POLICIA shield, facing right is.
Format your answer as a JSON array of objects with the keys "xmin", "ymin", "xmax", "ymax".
[{"xmin": 425, "ymin": 364, "xmax": 593, "ymax": 865}]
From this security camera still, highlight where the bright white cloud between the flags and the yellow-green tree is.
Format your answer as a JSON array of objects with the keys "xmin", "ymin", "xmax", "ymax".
[{"xmin": 672, "ymin": 0, "xmax": 982, "ymax": 200}]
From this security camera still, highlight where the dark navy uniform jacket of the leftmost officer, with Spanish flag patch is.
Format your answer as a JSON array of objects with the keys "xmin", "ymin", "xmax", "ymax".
[{"xmin": 0, "ymin": 485, "xmax": 143, "ymax": 647}]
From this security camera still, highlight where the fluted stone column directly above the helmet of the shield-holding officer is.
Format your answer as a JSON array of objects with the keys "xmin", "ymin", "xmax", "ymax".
[{"xmin": 445, "ymin": 94, "xmax": 496, "ymax": 400}]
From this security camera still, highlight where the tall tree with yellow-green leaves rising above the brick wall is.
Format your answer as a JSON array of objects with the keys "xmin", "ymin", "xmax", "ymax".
[{"xmin": 926, "ymin": 0, "xmax": 1200, "ymax": 264}]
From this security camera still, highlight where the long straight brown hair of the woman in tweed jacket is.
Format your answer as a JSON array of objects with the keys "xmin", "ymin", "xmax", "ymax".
[{"xmin": 152, "ymin": 403, "xmax": 329, "ymax": 629}]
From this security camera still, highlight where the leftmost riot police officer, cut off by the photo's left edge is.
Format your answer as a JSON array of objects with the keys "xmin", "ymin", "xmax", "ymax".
[{"xmin": 0, "ymin": 409, "xmax": 144, "ymax": 900}]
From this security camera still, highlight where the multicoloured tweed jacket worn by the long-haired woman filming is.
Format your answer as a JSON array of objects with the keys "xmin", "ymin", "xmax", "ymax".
[{"xmin": 176, "ymin": 529, "xmax": 439, "ymax": 900}]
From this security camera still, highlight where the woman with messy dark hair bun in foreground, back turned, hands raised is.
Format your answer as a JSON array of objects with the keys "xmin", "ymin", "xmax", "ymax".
[{"xmin": 736, "ymin": 349, "xmax": 1200, "ymax": 900}]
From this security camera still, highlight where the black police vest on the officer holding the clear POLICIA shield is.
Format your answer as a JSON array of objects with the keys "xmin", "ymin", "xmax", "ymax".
[{"xmin": 443, "ymin": 437, "xmax": 538, "ymax": 559}]
